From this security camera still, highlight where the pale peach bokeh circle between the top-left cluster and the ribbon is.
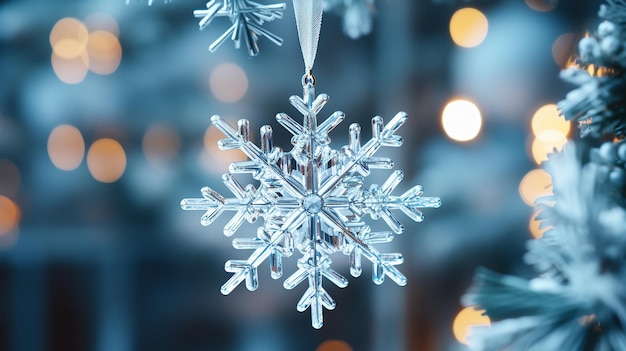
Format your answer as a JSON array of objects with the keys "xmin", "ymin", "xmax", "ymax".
[{"xmin": 209, "ymin": 63, "xmax": 248, "ymax": 103}]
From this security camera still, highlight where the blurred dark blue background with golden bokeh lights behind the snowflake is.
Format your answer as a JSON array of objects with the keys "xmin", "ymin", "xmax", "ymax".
[{"xmin": 0, "ymin": 0, "xmax": 600, "ymax": 351}]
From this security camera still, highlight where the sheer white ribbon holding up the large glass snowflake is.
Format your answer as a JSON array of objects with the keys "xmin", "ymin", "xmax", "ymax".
[{"xmin": 293, "ymin": 0, "xmax": 323, "ymax": 75}]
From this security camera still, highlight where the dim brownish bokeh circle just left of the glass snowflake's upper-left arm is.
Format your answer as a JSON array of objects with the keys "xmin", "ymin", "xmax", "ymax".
[{"xmin": 141, "ymin": 124, "xmax": 180, "ymax": 167}]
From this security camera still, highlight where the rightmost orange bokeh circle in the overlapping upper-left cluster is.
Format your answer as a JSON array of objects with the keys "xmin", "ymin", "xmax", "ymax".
[{"xmin": 87, "ymin": 30, "xmax": 122, "ymax": 75}]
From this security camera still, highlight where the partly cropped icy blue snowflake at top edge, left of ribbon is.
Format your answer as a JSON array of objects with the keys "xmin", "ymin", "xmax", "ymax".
[{"xmin": 193, "ymin": 0, "xmax": 286, "ymax": 56}]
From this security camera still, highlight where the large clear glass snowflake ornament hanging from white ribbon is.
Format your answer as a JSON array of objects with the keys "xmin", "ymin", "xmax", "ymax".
[{"xmin": 181, "ymin": 76, "xmax": 441, "ymax": 328}]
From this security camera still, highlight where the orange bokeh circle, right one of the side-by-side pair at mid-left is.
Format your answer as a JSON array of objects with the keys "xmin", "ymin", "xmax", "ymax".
[{"xmin": 87, "ymin": 138, "xmax": 126, "ymax": 183}]
